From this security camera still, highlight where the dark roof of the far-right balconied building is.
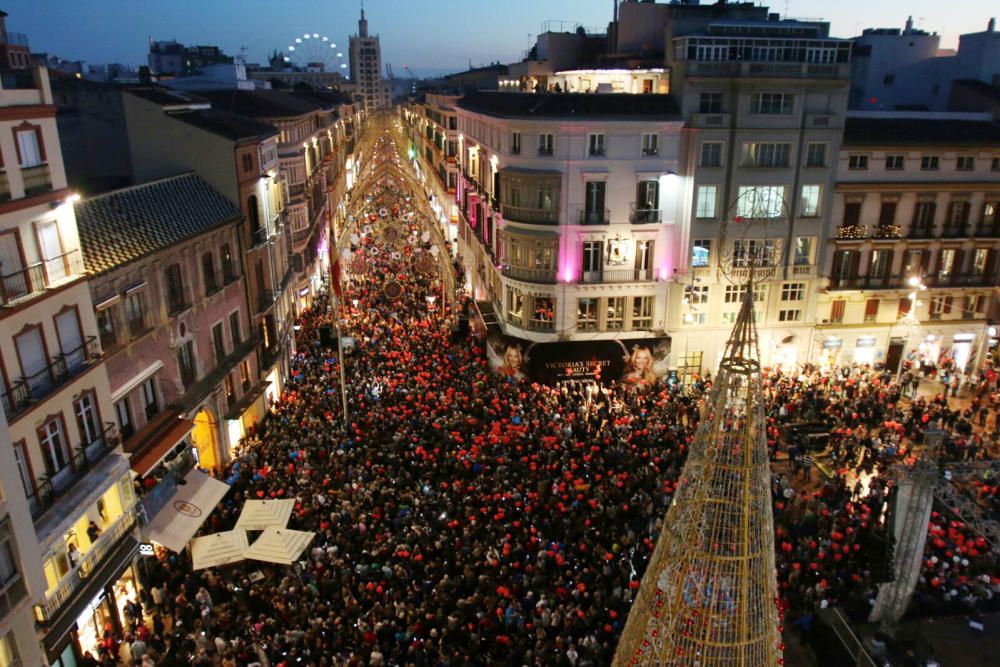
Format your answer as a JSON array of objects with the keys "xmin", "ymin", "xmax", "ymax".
[{"xmin": 844, "ymin": 112, "xmax": 1000, "ymax": 146}]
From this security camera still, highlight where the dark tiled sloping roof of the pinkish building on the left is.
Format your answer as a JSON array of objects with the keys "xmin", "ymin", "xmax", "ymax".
[{"xmin": 76, "ymin": 172, "xmax": 242, "ymax": 275}]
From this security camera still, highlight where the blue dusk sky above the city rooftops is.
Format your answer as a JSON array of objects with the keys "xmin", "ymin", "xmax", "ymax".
[{"xmin": 7, "ymin": 0, "xmax": 1000, "ymax": 75}]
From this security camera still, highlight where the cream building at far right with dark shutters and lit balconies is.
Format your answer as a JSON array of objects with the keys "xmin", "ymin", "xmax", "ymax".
[{"xmin": 810, "ymin": 112, "xmax": 1000, "ymax": 372}]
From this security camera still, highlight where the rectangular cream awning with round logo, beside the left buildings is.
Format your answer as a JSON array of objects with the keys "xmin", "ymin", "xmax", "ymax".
[{"xmin": 149, "ymin": 469, "xmax": 230, "ymax": 553}]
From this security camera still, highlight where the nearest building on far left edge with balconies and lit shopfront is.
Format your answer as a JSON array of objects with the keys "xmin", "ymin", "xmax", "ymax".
[{"xmin": 0, "ymin": 60, "xmax": 138, "ymax": 664}]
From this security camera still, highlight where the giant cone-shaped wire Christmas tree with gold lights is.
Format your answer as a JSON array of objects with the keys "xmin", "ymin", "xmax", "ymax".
[{"xmin": 614, "ymin": 281, "xmax": 781, "ymax": 667}]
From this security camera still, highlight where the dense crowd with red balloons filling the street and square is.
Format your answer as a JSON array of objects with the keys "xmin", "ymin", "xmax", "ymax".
[{"xmin": 95, "ymin": 140, "xmax": 1000, "ymax": 667}]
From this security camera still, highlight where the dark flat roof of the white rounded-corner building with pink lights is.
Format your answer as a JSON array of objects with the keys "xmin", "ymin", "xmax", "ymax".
[{"xmin": 458, "ymin": 91, "xmax": 680, "ymax": 120}]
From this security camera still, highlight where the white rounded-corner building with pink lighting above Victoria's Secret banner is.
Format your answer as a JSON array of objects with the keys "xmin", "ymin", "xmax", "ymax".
[{"xmin": 406, "ymin": 93, "xmax": 685, "ymax": 379}]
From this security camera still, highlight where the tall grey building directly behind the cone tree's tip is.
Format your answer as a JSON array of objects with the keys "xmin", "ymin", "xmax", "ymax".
[{"xmin": 667, "ymin": 15, "xmax": 851, "ymax": 372}]
